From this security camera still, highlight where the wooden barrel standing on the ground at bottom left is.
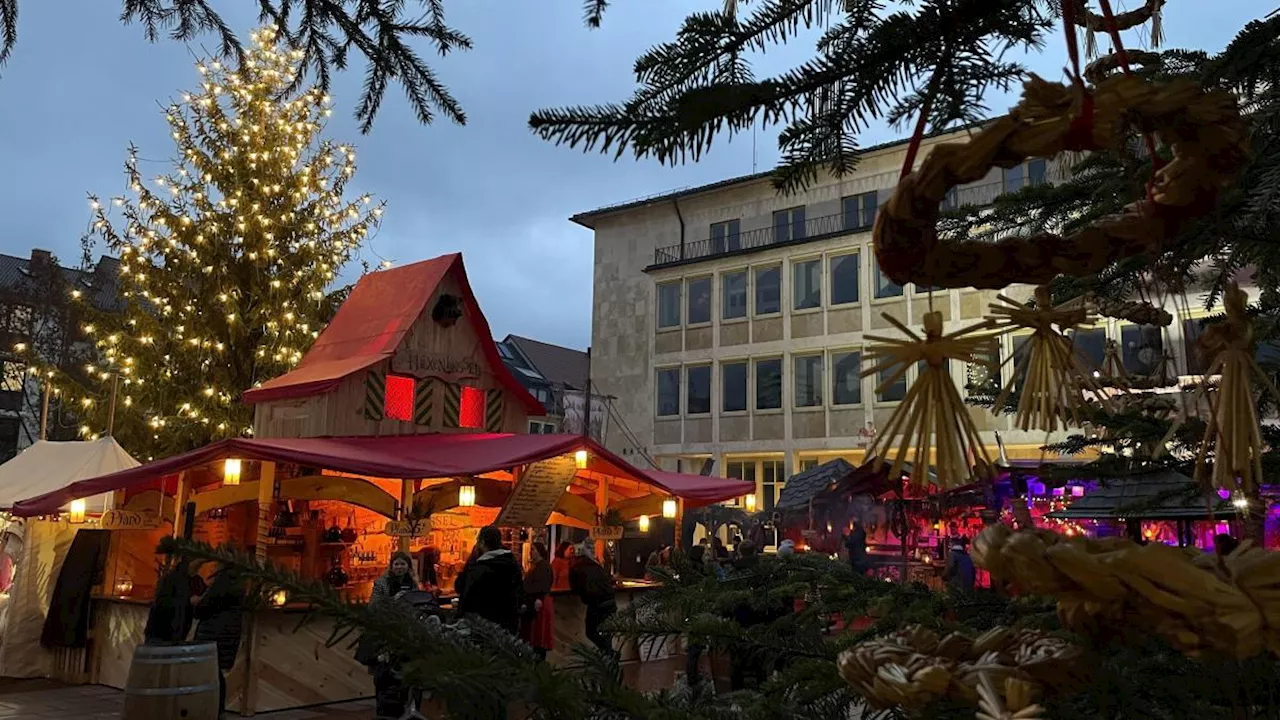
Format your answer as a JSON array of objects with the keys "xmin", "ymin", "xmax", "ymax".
[{"xmin": 122, "ymin": 643, "xmax": 218, "ymax": 720}]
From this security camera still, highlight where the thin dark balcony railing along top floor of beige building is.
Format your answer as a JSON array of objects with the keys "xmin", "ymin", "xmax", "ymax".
[{"xmin": 653, "ymin": 181, "xmax": 1034, "ymax": 268}]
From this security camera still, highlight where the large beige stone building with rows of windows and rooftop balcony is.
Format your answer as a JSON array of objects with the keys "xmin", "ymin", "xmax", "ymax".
[{"xmin": 572, "ymin": 126, "xmax": 1223, "ymax": 509}]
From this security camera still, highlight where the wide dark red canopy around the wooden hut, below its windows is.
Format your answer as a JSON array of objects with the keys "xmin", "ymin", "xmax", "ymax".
[{"xmin": 13, "ymin": 434, "xmax": 754, "ymax": 516}]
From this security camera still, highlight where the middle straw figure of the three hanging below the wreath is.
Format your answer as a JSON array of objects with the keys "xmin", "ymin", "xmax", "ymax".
[{"xmin": 991, "ymin": 286, "xmax": 1111, "ymax": 432}]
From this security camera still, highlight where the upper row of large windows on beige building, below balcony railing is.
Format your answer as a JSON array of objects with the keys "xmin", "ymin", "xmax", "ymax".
[{"xmin": 658, "ymin": 250, "xmax": 925, "ymax": 324}]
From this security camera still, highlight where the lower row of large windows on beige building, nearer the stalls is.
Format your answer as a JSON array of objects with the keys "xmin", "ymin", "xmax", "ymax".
[{"xmin": 657, "ymin": 350, "xmax": 906, "ymax": 418}]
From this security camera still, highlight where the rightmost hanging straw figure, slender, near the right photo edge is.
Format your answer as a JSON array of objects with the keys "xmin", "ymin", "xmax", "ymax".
[{"xmin": 1196, "ymin": 284, "xmax": 1280, "ymax": 493}]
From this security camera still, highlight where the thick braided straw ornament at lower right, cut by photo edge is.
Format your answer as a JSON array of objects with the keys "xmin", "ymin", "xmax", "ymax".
[{"xmin": 973, "ymin": 517, "xmax": 1280, "ymax": 660}]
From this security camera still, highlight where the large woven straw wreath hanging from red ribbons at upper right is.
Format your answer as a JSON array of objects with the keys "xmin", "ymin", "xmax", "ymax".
[{"xmin": 874, "ymin": 74, "xmax": 1248, "ymax": 290}]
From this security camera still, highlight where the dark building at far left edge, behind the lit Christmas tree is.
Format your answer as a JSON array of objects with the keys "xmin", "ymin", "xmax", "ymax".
[{"xmin": 0, "ymin": 250, "xmax": 120, "ymax": 461}]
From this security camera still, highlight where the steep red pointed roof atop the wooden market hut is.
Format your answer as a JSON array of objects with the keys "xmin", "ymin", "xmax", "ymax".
[{"xmin": 243, "ymin": 252, "xmax": 547, "ymax": 415}]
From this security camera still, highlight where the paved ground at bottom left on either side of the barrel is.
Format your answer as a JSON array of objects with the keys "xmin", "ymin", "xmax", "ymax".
[{"xmin": 0, "ymin": 680, "xmax": 374, "ymax": 720}]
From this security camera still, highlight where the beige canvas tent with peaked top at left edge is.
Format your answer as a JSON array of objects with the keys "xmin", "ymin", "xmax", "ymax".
[{"xmin": 0, "ymin": 437, "xmax": 138, "ymax": 678}]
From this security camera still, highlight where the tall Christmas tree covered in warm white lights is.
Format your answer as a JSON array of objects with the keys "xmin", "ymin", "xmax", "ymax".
[{"xmin": 35, "ymin": 28, "xmax": 383, "ymax": 457}]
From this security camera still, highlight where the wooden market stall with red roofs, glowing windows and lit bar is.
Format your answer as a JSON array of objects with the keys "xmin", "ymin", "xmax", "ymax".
[{"xmin": 7, "ymin": 255, "xmax": 750, "ymax": 714}]
